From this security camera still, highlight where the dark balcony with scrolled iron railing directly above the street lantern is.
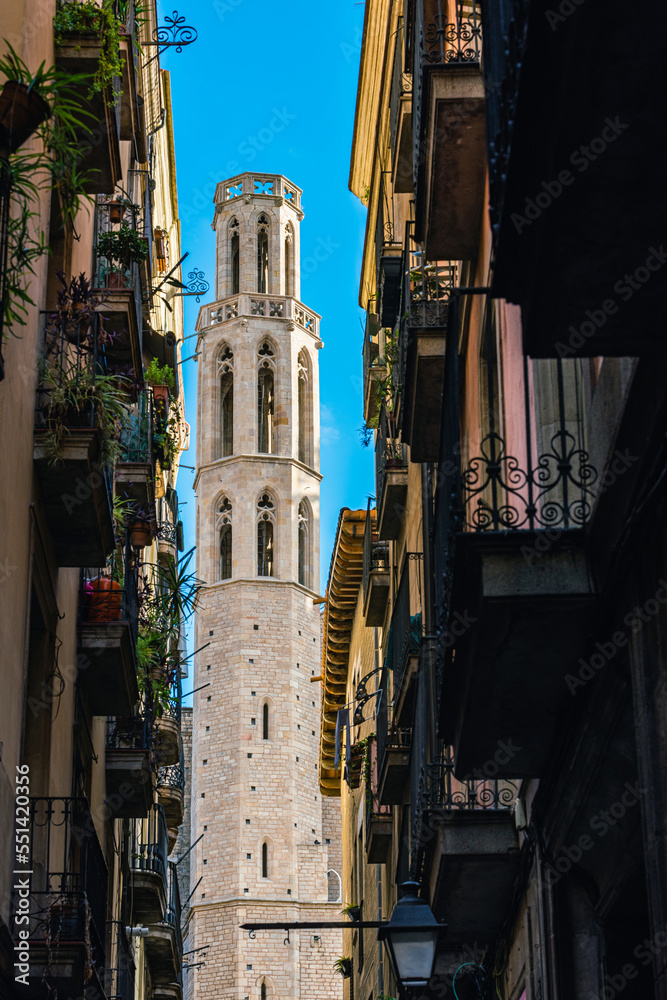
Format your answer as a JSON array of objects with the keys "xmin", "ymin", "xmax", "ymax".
[{"xmin": 417, "ymin": 751, "xmax": 520, "ymax": 948}]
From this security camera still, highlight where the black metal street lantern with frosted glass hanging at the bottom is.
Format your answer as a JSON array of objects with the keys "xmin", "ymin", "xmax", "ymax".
[{"xmin": 378, "ymin": 882, "xmax": 447, "ymax": 989}]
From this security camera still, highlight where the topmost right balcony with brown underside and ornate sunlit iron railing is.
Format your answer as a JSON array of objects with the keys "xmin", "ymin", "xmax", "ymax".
[{"xmin": 410, "ymin": 0, "xmax": 486, "ymax": 260}]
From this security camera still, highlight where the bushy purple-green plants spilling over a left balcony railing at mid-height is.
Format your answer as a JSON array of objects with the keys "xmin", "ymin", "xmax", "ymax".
[{"xmin": 41, "ymin": 360, "xmax": 127, "ymax": 466}]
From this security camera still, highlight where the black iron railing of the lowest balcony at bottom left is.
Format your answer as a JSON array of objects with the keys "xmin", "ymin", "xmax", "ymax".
[{"xmin": 17, "ymin": 797, "xmax": 107, "ymax": 975}]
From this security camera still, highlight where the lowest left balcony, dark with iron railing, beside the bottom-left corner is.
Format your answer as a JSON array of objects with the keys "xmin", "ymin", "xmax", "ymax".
[{"xmin": 15, "ymin": 798, "xmax": 107, "ymax": 1000}]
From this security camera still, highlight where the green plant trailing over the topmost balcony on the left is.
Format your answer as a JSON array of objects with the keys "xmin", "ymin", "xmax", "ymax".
[{"xmin": 53, "ymin": 0, "xmax": 125, "ymax": 106}]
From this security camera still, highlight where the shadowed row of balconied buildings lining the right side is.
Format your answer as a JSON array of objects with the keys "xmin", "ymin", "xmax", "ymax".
[{"xmin": 320, "ymin": 0, "xmax": 667, "ymax": 1000}]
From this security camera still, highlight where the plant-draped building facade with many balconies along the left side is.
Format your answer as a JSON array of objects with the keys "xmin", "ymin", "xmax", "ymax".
[{"xmin": 0, "ymin": 0, "xmax": 192, "ymax": 1000}]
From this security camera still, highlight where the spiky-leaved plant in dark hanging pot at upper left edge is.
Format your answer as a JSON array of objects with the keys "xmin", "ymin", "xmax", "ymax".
[{"xmin": 0, "ymin": 43, "xmax": 53, "ymax": 153}]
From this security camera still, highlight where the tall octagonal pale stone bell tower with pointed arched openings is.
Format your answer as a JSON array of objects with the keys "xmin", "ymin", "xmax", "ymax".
[{"xmin": 186, "ymin": 173, "xmax": 342, "ymax": 1000}]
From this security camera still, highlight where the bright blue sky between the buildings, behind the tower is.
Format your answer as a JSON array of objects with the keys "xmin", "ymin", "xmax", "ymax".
[{"xmin": 159, "ymin": 0, "xmax": 373, "ymax": 672}]
